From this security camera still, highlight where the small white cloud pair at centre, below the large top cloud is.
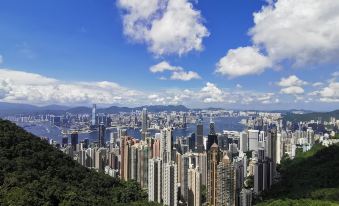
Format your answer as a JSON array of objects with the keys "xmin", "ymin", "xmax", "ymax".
[{"xmin": 150, "ymin": 61, "xmax": 201, "ymax": 81}]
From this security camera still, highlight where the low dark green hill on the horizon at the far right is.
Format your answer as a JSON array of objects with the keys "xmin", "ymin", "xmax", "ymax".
[{"xmin": 284, "ymin": 110, "xmax": 339, "ymax": 122}]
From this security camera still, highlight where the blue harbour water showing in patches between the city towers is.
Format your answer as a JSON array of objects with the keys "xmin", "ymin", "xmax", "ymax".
[{"xmin": 17, "ymin": 117, "xmax": 245, "ymax": 143}]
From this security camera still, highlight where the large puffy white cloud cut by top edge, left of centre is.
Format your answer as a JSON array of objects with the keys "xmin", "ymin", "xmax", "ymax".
[{"xmin": 117, "ymin": 0, "xmax": 209, "ymax": 55}]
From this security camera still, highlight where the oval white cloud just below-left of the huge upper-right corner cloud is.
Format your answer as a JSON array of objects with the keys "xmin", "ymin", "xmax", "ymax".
[{"xmin": 216, "ymin": 47, "xmax": 271, "ymax": 77}]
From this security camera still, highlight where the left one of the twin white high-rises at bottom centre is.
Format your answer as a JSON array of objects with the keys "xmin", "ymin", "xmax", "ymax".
[{"xmin": 148, "ymin": 158, "xmax": 163, "ymax": 203}]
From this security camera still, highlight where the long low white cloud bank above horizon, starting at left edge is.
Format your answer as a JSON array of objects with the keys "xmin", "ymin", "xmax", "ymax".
[{"xmin": 0, "ymin": 69, "xmax": 284, "ymax": 107}]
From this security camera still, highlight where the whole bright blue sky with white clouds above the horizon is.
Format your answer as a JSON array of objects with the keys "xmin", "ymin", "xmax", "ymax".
[{"xmin": 0, "ymin": 0, "xmax": 339, "ymax": 110}]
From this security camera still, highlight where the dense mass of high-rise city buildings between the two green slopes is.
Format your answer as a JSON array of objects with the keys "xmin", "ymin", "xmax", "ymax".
[{"xmin": 3, "ymin": 105, "xmax": 337, "ymax": 206}]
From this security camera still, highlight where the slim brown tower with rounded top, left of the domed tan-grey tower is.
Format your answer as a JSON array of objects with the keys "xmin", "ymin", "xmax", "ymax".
[{"xmin": 207, "ymin": 143, "xmax": 219, "ymax": 206}]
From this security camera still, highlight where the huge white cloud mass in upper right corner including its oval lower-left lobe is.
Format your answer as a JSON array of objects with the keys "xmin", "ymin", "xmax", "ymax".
[{"xmin": 216, "ymin": 0, "xmax": 339, "ymax": 76}]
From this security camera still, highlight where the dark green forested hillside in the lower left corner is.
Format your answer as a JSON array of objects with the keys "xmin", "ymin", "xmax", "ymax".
[{"xmin": 0, "ymin": 120, "xmax": 161, "ymax": 206}]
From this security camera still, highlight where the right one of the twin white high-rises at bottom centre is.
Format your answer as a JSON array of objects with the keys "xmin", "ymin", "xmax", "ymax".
[{"xmin": 163, "ymin": 161, "xmax": 178, "ymax": 206}]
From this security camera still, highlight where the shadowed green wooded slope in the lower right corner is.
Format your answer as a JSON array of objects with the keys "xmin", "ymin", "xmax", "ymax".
[{"xmin": 259, "ymin": 144, "xmax": 339, "ymax": 205}]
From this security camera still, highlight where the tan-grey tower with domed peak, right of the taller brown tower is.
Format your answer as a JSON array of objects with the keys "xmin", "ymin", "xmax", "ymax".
[{"xmin": 216, "ymin": 154, "xmax": 235, "ymax": 206}]
